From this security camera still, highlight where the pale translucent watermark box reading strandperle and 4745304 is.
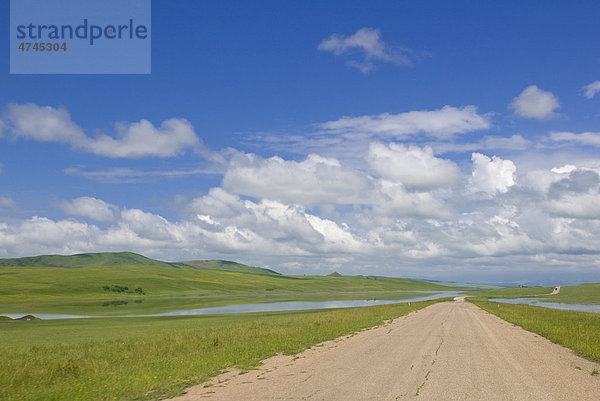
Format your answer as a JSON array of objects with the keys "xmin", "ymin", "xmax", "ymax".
[{"xmin": 10, "ymin": 0, "xmax": 152, "ymax": 74}]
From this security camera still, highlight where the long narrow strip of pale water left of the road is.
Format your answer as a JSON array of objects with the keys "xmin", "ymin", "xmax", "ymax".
[{"xmin": 0, "ymin": 291, "xmax": 461, "ymax": 320}]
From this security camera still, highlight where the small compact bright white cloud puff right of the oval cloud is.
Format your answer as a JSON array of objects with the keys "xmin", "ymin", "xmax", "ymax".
[{"xmin": 471, "ymin": 153, "xmax": 517, "ymax": 195}]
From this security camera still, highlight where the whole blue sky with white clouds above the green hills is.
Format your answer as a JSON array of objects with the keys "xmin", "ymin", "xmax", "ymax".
[{"xmin": 0, "ymin": 1, "xmax": 600, "ymax": 284}]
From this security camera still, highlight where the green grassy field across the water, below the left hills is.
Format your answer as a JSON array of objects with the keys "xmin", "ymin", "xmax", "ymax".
[{"xmin": 0, "ymin": 254, "xmax": 453, "ymax": 316}]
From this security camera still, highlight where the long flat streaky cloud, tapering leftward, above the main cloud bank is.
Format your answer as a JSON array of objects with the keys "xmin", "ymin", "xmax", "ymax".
[{"xmin": 319, "ymin": 106, "xmax": 490, "ymax": 138}]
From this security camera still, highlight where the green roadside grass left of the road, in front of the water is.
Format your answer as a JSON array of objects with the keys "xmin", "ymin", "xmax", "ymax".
[{"xmin": 0, "ymin": 300, "xmax": 440, "ymax": 401}]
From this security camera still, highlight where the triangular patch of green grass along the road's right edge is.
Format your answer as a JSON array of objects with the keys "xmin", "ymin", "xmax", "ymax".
[{"xmin": 467, "ymin": 298, "xmax": 600, "ymax": 362}]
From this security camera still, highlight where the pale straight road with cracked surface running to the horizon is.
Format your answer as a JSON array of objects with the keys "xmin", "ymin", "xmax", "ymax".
[{"xmin": 168, "ymin": 299, "xmax": 600, "ymax": 401}]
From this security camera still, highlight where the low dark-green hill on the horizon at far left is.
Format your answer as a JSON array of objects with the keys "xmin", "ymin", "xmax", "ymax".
[{"xmin": 0, "ymin": 252, "xmax": 172, "ymax": 268}]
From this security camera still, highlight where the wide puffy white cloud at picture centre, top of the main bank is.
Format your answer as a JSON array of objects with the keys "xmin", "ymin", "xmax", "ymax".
[{"xmin": 223, "ymin": 154, "xmax": 373, "ymax": 205}]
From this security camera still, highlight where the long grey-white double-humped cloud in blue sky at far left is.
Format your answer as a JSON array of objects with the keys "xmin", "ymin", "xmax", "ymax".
[{"xmin": 5, "ymin": 103, "xmax": 206, "ymax": 158}]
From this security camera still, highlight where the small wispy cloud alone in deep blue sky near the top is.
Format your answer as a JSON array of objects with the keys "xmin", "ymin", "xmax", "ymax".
[{"xmin": 318, "ymin": 28, "xmax": 412, "ymax": 74}]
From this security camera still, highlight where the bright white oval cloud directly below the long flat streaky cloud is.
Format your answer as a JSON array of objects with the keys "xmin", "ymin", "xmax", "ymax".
[{"xmin": 367, "ymin": 143, "xmax": 461, "ymax": 191}]
